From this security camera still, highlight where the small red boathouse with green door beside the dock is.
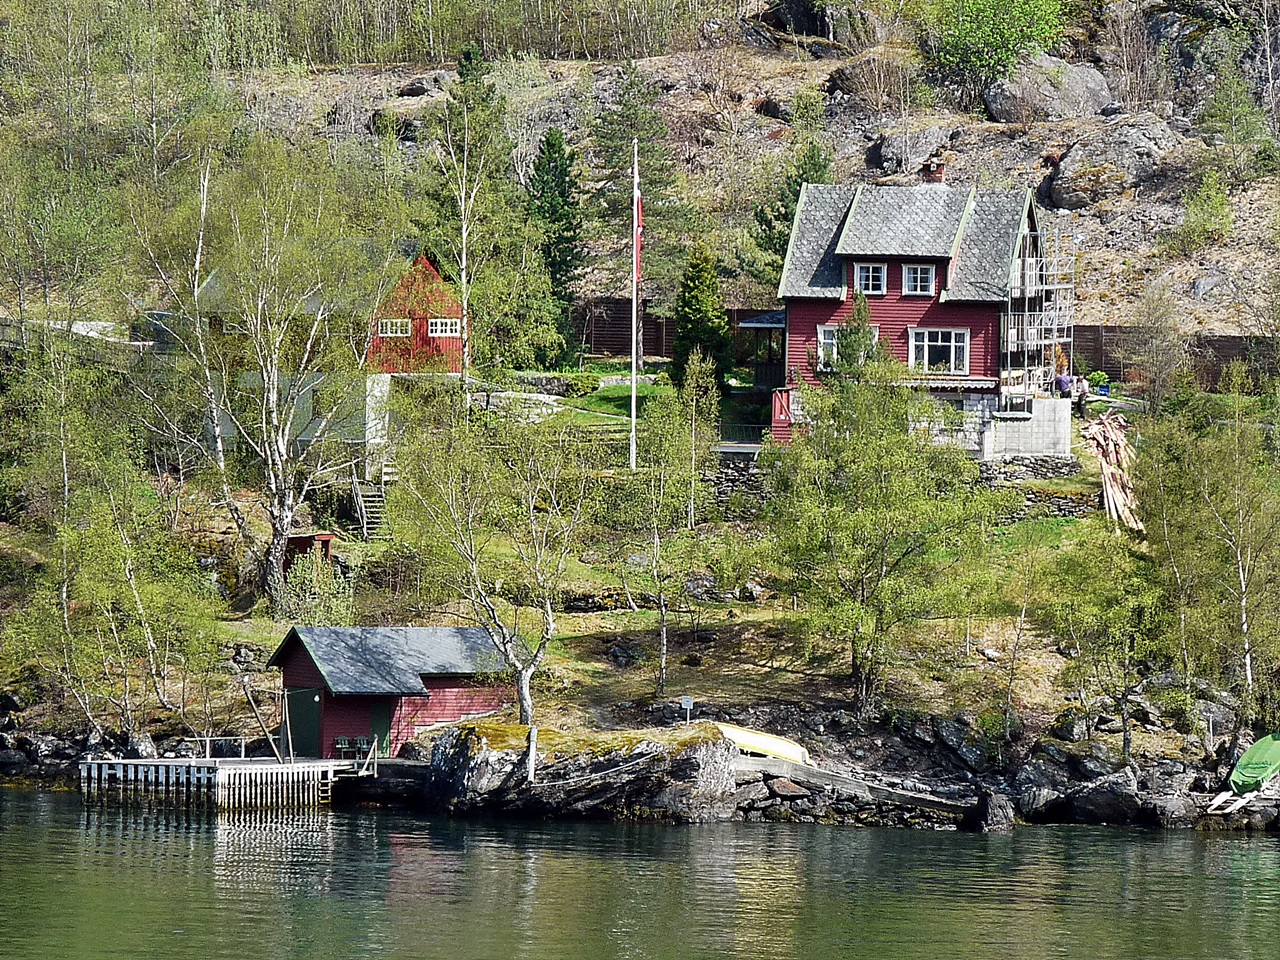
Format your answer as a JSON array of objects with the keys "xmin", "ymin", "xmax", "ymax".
[{"xmin": 268, "ymin": 627, "xmax": 512, "ymax": 759}]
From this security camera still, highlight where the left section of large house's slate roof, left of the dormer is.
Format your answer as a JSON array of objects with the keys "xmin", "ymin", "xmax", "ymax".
[{"xmin": 778, "ymin": 183, "xmax": 855, "ymax": 300}]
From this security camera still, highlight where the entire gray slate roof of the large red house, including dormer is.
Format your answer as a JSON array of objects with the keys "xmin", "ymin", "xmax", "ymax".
[{"xmin": 778, "ymin": 184, "xmax": 1029, "ymax": 301}]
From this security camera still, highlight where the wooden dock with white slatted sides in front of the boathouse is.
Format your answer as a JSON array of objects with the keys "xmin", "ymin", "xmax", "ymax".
[{"xmin": 79, "ymin": 758, "xmax": 375, "ymax": 810}]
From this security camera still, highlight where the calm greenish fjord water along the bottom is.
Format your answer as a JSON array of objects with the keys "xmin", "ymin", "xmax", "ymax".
[{"xmin": 0, "ymin": 790, "xmax": 1280, "ymax": 960}]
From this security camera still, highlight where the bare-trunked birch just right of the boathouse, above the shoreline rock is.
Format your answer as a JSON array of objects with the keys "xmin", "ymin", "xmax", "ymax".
[{"xmin": 388, "ymin": 407, "xmax": 603, "ymax": 724}]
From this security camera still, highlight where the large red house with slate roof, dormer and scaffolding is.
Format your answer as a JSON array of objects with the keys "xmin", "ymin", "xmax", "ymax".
[{"xmin": 772, "ymin": 184, "xmax": 1074, "ymax": 440}]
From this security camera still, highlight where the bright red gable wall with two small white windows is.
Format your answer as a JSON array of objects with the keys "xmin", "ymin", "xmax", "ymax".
[{"xmin": 369, "ymin": 253, "xmax": 462, "ymax": 374}]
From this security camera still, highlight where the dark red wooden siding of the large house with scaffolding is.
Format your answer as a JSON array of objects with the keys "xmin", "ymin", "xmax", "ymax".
[{"xmin": 773, "ymin": 260, "xmax": 1001, "ymax": 440}]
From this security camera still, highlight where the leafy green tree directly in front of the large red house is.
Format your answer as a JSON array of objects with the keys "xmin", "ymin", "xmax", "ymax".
[{"xmin": 762, "ymin": 361, "xmax": 1005, "ymax": 710}]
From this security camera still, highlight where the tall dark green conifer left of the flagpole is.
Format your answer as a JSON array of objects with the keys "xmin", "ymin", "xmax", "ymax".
[{"xmin": 529, "ymin": 127, "xmax": 585, "ymax": 308}]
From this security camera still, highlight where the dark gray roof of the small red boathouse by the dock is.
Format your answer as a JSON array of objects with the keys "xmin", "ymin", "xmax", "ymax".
[{"xmin": 268, "ymin": 627, "xmax": 502, "ymax": 695}]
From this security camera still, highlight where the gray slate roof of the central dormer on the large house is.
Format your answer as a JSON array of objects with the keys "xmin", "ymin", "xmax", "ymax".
[{"xmin": 836, "ymin": 186, "xmax": 969, "ymax": 257}]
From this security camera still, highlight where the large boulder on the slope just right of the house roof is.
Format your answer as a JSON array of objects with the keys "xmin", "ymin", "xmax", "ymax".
[{"xmin": 1048, "ymin": 113, "xmax": 1184, "ymax": 210}]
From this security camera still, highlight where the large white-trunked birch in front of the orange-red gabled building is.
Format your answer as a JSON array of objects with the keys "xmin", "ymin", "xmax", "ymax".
[{"xmin": 131, "ymin": 137, "xmax": 397, "ymax": 600}]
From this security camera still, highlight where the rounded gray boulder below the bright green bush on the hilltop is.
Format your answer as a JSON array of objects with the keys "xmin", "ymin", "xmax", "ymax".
[{"xmin": 982, "ymin": 54, "xmax": 1111, "ymax": 123}]
